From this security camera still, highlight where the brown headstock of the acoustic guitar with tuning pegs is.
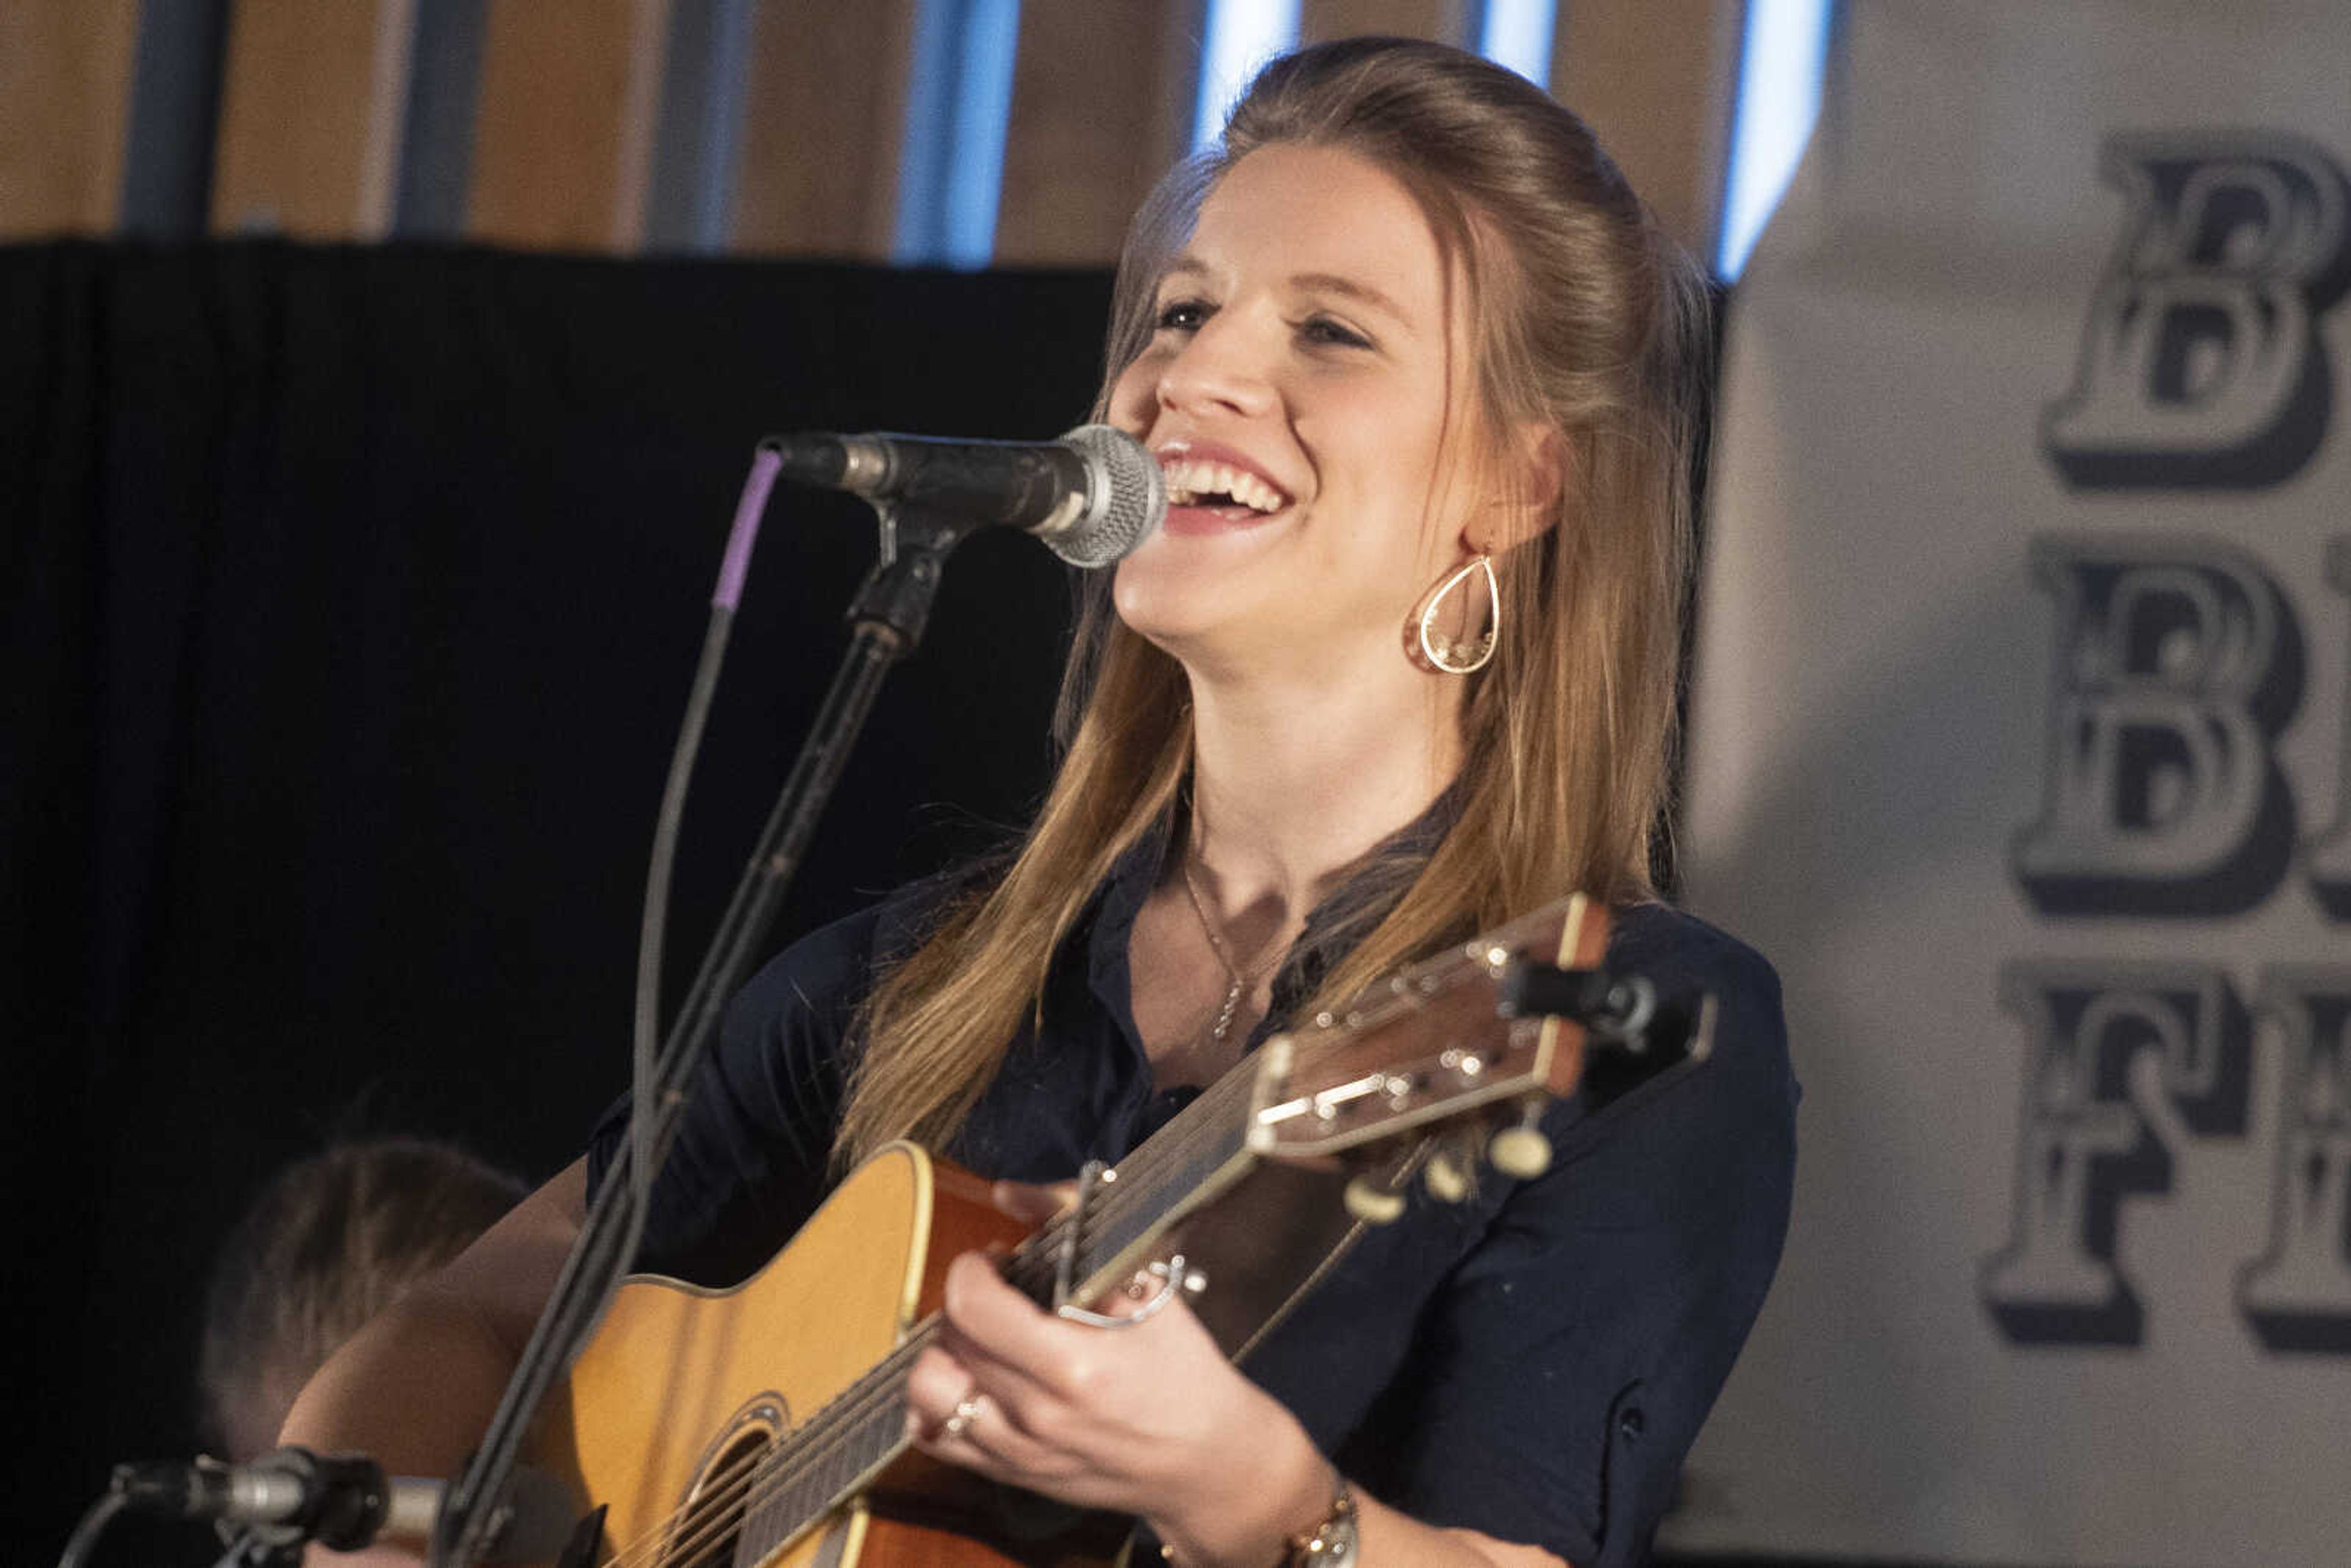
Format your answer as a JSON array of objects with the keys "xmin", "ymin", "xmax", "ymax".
[{"xmin": 1248, "ymin": 893, "xmax": 1608, "ymax": 1159}]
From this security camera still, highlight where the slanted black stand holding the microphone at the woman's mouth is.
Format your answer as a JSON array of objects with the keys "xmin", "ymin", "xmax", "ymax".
[{"xmin": 433, "ymin": 501, "xmax": 971, "ymax": 1568}]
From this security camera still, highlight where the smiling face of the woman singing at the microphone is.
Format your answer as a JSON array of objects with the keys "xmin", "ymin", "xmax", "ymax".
[{"xmin": 1109, "ymin": 146, "xmax": 1472, "ymax": 672}]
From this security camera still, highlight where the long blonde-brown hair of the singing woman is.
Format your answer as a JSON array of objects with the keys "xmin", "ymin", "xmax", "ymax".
[{"xmin": 834, "ymin": 37, "xmax": 1707, "ymax": 1161}]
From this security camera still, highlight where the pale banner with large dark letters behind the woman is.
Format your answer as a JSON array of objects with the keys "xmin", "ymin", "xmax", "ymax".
[{"xmin": 1667, "ymin": 0, "xmax": 2351, "ymax": 1568}]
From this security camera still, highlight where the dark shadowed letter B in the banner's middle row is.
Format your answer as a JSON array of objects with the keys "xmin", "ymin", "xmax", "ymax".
[{"xmin": 2015, "ymin": 538, "xmax": 2301, "ymax": 915}]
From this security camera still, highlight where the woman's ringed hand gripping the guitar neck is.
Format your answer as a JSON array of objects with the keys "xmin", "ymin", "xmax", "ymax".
[{"xmin": 907, "ymin": 1253, "xmax": 1330, "ymax": 1561}]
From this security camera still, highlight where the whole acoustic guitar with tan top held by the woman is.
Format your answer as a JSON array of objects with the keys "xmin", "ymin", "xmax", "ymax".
[{"xmin": 531, "ymin": 898, "xmax": 1702, "ymax": 1568}]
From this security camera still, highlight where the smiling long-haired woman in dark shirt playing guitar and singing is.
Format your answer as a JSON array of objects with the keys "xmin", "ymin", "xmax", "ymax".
[{"xmin": 287, "ymin": 40, "xmax": 1791, "ymax": 1568}]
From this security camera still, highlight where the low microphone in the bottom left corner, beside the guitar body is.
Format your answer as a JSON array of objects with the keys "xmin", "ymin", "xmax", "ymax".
[{"xmin": 113, "ymin": 1446, "xmax": 579, "ymax": 1563}]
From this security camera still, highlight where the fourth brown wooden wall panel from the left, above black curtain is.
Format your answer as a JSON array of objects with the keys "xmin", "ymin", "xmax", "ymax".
[{"xmin": 733, "ymin": 0, "xmax": 915, "ymax": 258}]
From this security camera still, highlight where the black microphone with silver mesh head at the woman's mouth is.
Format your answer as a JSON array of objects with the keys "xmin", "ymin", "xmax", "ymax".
[{"xmin": 759, "ymin": 426, "xmax": 1168, "ymax": 566}]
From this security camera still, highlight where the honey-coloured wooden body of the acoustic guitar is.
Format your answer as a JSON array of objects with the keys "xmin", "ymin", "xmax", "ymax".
[{"xmin": 531, "ymin": 1145, "xmax": 1114, "ymax": 1568}]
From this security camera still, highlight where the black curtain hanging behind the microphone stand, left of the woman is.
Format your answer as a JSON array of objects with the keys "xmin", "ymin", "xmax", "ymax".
[{"xmin": 0, "ymin": 242, "xmax": 1109, "ymax": 1561}]
